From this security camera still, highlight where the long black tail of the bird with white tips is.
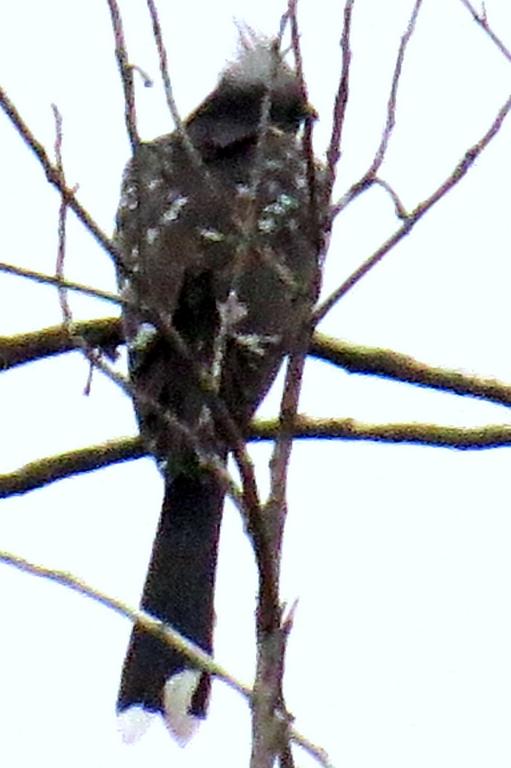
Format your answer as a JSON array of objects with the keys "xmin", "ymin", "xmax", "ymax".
[{"xmin": 117, "ymin": 471, "xmax": 224, "ymax": 742}]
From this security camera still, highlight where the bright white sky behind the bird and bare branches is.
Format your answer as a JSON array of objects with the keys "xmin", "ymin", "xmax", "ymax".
[{"xmin": 0, "ymin": 0, "xmax": 511, "ymax": 768}]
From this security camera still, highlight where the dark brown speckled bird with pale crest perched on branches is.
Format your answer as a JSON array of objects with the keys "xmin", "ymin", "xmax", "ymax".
[{"xmin": 115, "ymin": 34, "xmax": 319, "ymax": 744}]
